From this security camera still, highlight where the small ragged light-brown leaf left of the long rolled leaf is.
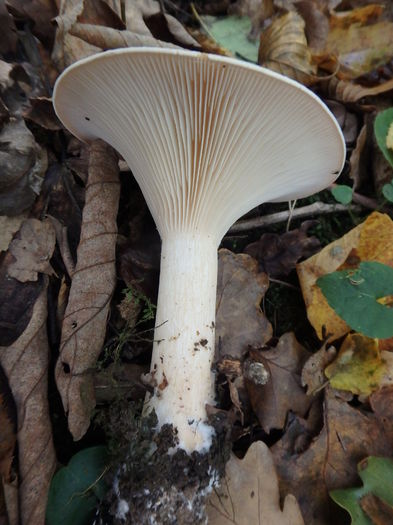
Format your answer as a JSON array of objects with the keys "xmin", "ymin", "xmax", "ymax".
[{"xmin": 8, "ymin": 219, "xmax": 56, "ymax": 283}]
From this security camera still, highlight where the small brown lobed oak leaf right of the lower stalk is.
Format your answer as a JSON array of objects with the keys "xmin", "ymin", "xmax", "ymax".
[{"xmin": 246, "ymin": 333, "xmax": 312, "ymax": 433}]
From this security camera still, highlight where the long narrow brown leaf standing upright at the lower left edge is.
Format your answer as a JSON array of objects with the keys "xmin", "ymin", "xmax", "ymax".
[{"xmin": 0, "ymin": 277, "xmax": 56, "ymax": 524}]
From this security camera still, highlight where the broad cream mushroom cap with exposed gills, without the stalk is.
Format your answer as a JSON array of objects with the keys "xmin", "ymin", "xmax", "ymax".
[{"xmin": 53, "ymin": 48, "xmax": 345, "ymax": 241}]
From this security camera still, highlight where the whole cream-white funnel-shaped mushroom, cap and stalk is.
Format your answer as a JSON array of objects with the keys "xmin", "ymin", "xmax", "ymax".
[{"xmin": 54, "ymin": 48, "xmax": 345, "ymax": 453}]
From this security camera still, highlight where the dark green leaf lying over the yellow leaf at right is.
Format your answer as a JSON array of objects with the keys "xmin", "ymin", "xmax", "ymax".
[{"xmin": 317, "ymin": 262, "xmax": 393, "ymax": 339}]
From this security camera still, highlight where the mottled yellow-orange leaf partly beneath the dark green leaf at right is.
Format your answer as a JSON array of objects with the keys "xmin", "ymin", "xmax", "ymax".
[{"xmin": 297, "ymin": 212, "xmax": 393, "ymax": 340}]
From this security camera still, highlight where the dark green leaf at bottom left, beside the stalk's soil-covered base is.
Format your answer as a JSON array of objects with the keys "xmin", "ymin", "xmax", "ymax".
[{"xmin": 46, "ymin": 446, "xmax": 108, "ymax": 525}]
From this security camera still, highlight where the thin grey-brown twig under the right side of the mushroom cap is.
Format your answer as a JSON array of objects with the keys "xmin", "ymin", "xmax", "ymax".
[{"xmin": 228, "ymin": 202, "xmax": 361, "ymax": 234}]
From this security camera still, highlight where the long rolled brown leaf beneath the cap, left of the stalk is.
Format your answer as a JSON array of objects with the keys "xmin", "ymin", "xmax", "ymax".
[{"xmin": 56, "ymin": 140, "xmax": 120, "ymax": 439}]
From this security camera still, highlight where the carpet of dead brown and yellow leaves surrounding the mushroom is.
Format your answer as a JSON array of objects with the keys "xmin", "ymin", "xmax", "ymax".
[{"xmin": 0, "ymin": 0, "xmax": 393, "ymax": 525}]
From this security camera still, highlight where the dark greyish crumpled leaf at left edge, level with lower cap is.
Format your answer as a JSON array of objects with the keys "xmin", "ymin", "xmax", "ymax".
[{"xmin": 0, "ymin": 119, "xmax": 48, "ymax": 215}]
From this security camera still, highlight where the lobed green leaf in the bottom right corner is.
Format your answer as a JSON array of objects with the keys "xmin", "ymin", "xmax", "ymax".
[{"xmin": 330, "ymin": 456, "xmax": 393, "ymax": 525}]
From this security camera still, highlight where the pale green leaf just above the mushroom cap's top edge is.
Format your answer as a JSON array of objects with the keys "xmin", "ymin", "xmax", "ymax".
[{"xmin": 201, "ymin": 16, "xmax": 259, "ymax": 62}]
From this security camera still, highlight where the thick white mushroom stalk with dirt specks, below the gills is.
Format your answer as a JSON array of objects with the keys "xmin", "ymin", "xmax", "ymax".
[{"xmin": 146, "ymin": 233, "xmax": 217, "ymax": 452}]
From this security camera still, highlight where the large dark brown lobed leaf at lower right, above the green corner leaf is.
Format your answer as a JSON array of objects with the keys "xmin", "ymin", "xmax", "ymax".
[{"xmin": 271, "ymin": 389, "xmax": 393, "ymax": 525}]
